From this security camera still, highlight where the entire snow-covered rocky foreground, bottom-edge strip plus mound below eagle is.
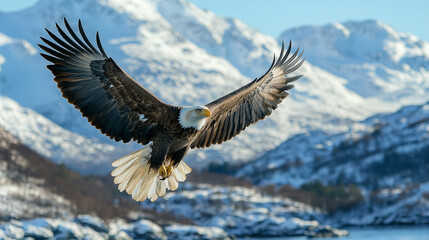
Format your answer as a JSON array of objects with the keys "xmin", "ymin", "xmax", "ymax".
[{"xmin": 0, "ymin": 184, "xmax": 348, "ymax": 240}]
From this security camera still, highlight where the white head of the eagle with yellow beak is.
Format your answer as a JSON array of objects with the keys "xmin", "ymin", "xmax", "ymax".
[{"xmin": 179, "ymin": 106, "xmax": 211, "ymax": 130}]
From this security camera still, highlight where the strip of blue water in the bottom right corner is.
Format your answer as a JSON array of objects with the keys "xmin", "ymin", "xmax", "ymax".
[{"xmin": 239, "ymin": 225, "xmax": 429, "ymax": 240}]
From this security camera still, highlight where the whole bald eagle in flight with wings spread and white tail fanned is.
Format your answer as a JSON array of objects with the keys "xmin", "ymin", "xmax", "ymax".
[{"xmin": 39, "ymin": 19, "xmax": 304, "ymax": 201}]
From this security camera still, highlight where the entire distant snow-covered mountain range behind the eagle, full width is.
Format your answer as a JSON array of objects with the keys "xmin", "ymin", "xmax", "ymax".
[{"xmin": 0, "ymin": 0, "xmax": 429, "ymax": 173}]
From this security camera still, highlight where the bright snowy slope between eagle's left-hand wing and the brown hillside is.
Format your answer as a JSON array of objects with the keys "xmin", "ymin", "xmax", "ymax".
[{"xmin": 0, "ymin": 96, "xmax": 133, "ymax": 174}]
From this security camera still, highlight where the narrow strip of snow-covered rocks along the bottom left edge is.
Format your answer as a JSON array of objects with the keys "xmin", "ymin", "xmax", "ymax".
[{"xmin": 0, "ymin": 215, "xmax": 231, "ymax": 240}]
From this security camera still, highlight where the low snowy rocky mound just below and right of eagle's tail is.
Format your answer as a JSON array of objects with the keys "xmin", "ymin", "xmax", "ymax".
[{"xmin": 142, "ymin": 183, "xmax": 348, "ymax": 237}]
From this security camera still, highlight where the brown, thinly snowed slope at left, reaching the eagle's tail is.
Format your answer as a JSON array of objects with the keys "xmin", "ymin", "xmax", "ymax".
[{"xmin": 0, "ymin": 124, "xmax": 138, "ymax": 220}]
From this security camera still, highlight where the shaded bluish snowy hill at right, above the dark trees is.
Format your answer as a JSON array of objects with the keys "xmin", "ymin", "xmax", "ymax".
[{"xmin": 238, "ymin": 102, "xmax": 429, "ymax": 190}]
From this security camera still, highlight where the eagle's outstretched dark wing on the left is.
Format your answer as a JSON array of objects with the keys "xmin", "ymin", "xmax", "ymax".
[{"xmin": 39, "ymin": 18, "xmax": 173, "ymax": 144}]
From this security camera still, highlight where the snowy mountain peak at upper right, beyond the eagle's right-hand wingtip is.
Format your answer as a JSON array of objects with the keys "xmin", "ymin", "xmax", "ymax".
[{"xmin": 280, "ymin": 20, "xmax": 429, "ymax": 109}]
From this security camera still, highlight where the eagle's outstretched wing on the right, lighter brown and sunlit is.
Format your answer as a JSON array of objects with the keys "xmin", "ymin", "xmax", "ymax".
[{"xmin": 191, "ymin": 43, "xmax": 304, "ymax": 148}]
